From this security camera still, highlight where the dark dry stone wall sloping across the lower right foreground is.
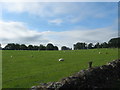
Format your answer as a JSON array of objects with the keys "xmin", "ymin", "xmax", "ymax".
[{"xmin": 31, "ymin": 59, "xmax": 120, "ymax": 90}]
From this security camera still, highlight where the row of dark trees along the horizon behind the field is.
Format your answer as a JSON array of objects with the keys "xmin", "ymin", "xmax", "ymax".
[{"xmin": 0, "ymin": 37, "xmax": 120, "ymax": 50}]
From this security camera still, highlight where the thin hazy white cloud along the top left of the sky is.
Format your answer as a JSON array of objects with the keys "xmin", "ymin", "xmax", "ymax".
[{"xmin": 2, "ymin": 2, "xmax": 75, "ymax": 17}]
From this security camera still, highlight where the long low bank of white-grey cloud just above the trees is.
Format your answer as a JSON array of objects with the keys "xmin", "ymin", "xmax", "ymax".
[{"xmin": 0, "ymin": 21, "xmax": 118, "ymax": 48}]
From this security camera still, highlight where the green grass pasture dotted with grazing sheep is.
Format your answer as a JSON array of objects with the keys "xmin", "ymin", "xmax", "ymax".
[{"xmin": 2, "ymin": 49, "xmax": 118, "ymax": 88}]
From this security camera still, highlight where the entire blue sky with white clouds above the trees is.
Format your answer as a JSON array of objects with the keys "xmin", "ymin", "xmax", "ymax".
[{"xmin": 0, "ymin": 2, "xmax": 118, "ymax": 47}]
